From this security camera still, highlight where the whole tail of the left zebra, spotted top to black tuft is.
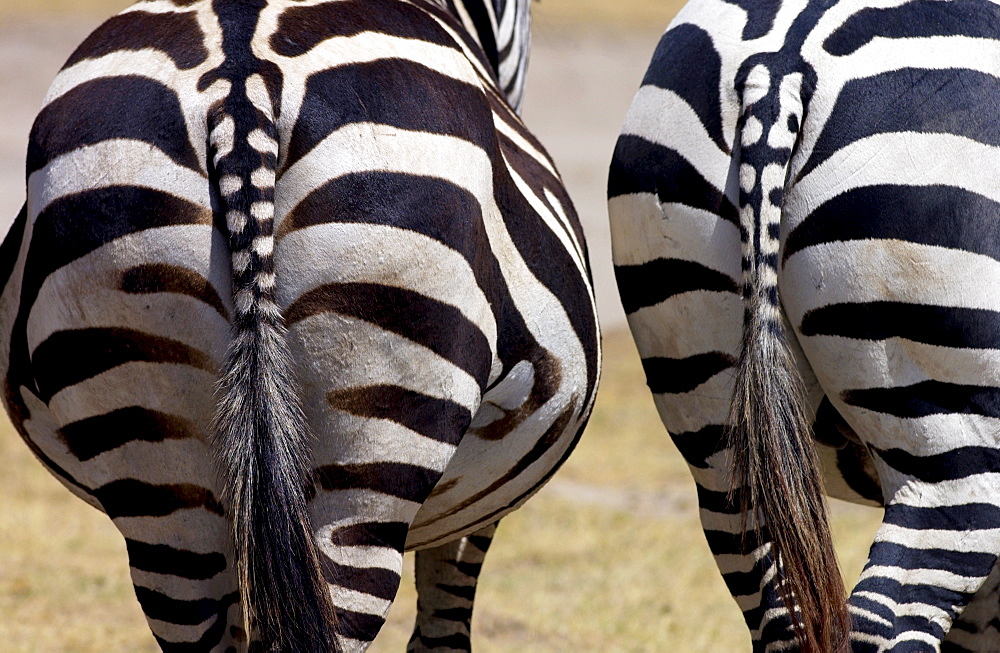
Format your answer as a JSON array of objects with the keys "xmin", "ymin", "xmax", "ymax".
[{"xmin": 210, "ymin": 98, "xmax": 339, "ymax": 653}]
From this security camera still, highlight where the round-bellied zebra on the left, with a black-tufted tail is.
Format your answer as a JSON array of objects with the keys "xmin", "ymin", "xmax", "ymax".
[{"xmin": 0, "ymin": 0, "xmax": 601, "ymax": 652}]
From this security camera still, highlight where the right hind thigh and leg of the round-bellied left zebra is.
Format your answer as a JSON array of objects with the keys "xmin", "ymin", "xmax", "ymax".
[{"xmin": 275, "ymin": 215, "xmax": 493, "ymax": 650}]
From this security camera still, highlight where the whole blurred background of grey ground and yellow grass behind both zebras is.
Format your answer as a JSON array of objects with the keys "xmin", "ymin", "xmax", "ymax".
[{"xmin": 0, "ymin": 0, "xmax": 880, "ymax": 653}]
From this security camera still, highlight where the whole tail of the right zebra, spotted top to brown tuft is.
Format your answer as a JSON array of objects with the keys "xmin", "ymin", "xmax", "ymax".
[{"xmin": 728, "ymin": 71, "xmax": 850, "ymax": 653}]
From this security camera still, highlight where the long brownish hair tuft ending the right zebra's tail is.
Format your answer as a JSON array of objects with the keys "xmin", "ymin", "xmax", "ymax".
[{"xmin": 729, "ymin": 290, "xmax": 850, "ymax": 653}]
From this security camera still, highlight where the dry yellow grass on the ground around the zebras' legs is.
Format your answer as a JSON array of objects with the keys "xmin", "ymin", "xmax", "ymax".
[{"xmin": 0, "ymin": 332, "xmax": 879, "ymax": 653}]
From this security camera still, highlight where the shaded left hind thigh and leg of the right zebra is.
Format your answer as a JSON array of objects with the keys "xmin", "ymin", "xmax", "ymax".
[{"xmin": 611, "ymin": 194, "xmax": 804, "ymax": 641}]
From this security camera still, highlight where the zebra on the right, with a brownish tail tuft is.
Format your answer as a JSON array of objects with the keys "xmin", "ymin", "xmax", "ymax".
[{"xmin": 608, "ymin": 0, "xmax": 1000, "ymax": 652}]
